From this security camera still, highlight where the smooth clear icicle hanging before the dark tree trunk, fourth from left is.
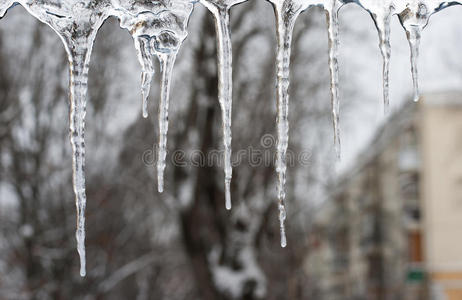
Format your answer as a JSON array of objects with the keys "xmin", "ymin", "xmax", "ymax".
[{"xmin": 212, "ymin": 8, "xmax": 233, "ymax": 210}]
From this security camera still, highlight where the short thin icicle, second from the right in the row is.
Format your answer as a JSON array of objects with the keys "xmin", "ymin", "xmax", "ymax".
[{"xmin": 372, "ymin": 12, "xmax": 391, "ymax": 113}]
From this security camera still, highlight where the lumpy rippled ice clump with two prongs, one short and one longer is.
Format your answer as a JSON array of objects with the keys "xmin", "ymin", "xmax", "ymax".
[{"xmin": 114, "ymin": 0, "xmax": 193, "ymax": 192}]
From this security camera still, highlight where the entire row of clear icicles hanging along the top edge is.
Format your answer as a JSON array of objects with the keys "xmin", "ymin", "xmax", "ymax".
[{"xmin": 0, "ymin": 0, "xmax": 462, "ymax": 276}]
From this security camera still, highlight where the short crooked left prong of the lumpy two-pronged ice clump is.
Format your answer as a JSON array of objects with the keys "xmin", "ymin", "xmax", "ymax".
[{"xmin": 135, "ymin": 37, "xmax": 154, "ymax": 118}]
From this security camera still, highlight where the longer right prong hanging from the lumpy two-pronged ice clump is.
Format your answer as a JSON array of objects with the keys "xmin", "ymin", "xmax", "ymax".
[{"xmin": 157, "ymin": 50, "xmax": 176, "ymax": 193}]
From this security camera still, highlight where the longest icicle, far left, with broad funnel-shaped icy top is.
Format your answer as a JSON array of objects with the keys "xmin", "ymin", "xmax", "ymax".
[{"xmin": 9, "ymin": 1, "xmax": 107, "ymax": 277}]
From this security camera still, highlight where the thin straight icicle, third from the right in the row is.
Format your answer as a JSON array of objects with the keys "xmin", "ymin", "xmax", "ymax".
[{"xmin": 325, "ymin": 0, "xmax": 341, "ymax": 159}]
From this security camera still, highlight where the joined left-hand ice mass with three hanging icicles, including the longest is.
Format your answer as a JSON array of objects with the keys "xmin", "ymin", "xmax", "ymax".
[{"xmin": 0, "ymin": 0, "xmax": 193, "ymax": 276}]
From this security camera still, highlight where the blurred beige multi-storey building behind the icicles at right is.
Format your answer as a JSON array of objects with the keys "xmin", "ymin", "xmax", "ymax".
[{"xmin": 305, "ymin": 93, "xmax": 462, "ymax": 300}]
